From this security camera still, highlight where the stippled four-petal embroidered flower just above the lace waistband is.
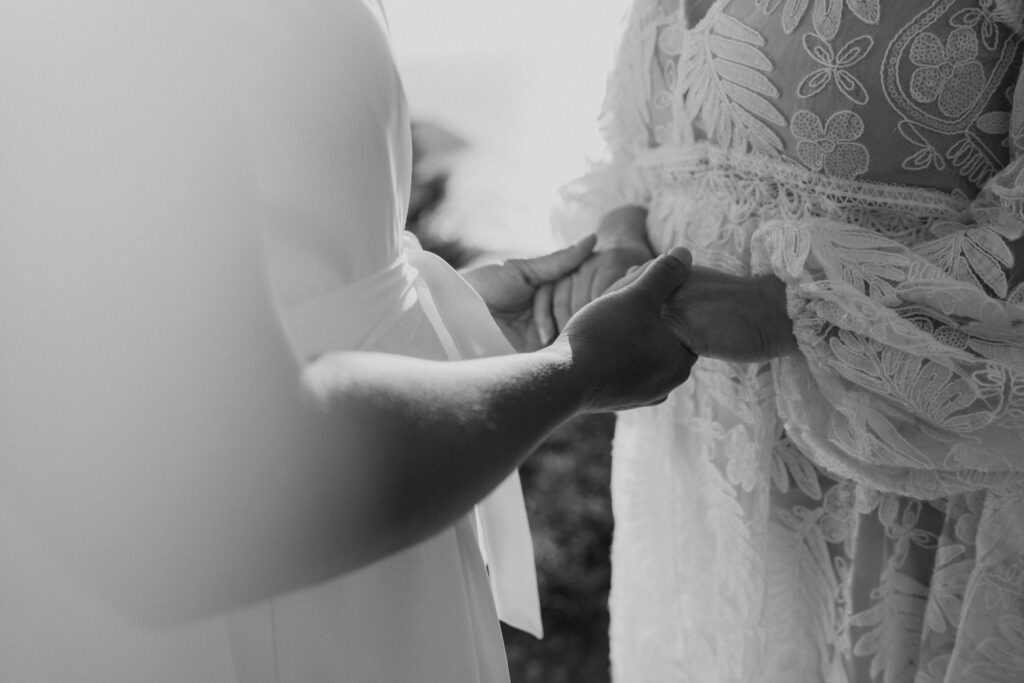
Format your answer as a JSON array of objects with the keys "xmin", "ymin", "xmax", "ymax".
[{"xmin": 790, "ymin": 110, "xmax": 868, "ymax": 179}]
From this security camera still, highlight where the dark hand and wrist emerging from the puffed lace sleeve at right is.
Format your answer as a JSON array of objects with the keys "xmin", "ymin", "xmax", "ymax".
[{"xmin": 664, "ymin": 266, "xmax": 797, "ymax": 362}]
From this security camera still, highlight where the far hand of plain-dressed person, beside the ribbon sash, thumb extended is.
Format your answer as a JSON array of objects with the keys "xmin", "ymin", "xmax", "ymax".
[{"xmin": 462, "ymin": 236, "xmax": 595, "ymax": 351}]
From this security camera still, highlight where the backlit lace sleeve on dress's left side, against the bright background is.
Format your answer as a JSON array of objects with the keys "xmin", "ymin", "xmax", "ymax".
[{"xmin": 554, "ymin": 0, "xmax": 665, "ymax": 242}]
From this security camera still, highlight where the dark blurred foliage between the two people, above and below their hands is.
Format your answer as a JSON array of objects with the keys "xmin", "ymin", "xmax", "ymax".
[{"xmin": 407, "ymin": 122, "xmax": 614, "ymax": 683}]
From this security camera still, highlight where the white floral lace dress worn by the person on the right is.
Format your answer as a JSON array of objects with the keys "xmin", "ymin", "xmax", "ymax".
[{"xmin": 567, "ymin": 0, "xmax": 1024, "ymax": 683}]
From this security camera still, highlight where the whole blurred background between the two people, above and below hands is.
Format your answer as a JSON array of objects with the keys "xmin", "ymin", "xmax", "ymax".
[{"xmin": 393, "ymin": 0, "xmax": 629, "ymax": 683}]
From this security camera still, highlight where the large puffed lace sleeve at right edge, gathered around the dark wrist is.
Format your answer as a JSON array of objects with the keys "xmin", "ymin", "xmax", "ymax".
[{"xmin": 754, "ymin": 60, "xmax": 1024, "ymax": 498}]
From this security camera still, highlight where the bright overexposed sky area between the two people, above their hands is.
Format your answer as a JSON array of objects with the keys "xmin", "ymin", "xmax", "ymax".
[{"xmin": 384, "ymin": 0, "xmax": 628, "ymax": 253}]
